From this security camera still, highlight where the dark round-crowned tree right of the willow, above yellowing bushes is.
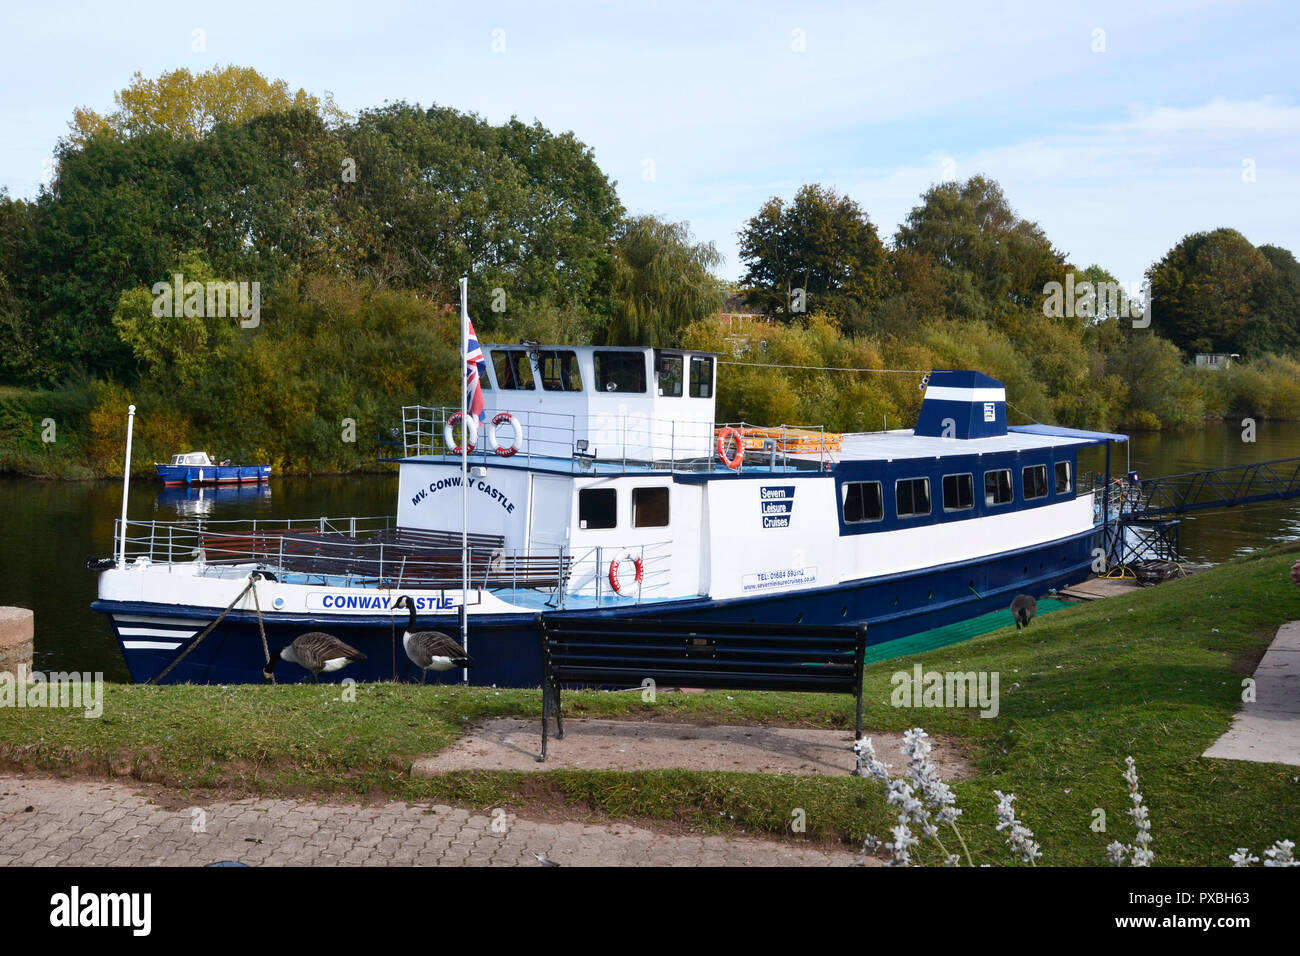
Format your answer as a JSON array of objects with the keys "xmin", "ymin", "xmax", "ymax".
[{"xmin": 740, "ymin": 185, "xmax": 888, "ymax": 328}]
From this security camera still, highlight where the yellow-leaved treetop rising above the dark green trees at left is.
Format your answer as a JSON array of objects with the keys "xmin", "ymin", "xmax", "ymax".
[{"xmin": 69, "ymin": 66, "xmax": 347, "ymax": 146}]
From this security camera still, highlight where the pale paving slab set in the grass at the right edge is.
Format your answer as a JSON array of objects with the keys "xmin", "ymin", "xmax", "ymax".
[{"xmin": 1204, "ymin": 620, "xmax": 1300, "ymax": 766}]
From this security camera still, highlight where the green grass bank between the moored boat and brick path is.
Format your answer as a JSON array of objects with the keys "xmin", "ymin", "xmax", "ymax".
[{"xmin": 0, "ymin": 545, "xmax": 1300, "ymax": 865}]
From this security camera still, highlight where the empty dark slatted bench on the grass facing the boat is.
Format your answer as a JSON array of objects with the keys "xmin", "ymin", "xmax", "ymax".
[{"xmin": 536, "ymin": 614, "xmax": 867, "ymax": 773}]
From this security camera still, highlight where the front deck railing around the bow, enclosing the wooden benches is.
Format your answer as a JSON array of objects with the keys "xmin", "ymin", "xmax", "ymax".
[{"xmin": 114, "ymin": 516, "xmax": 672, "ymax": 607}]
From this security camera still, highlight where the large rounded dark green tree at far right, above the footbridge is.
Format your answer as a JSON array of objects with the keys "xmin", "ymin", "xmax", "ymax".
[{"xmin": 1147, "ymin": 229, "xmax": 1274, "ymax": 355}]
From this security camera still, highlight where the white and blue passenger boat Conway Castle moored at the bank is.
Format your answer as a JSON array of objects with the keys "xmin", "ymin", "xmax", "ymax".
[{"xmin": 94, "ymin": 346, "xmax": 1125, "ymax": 687}]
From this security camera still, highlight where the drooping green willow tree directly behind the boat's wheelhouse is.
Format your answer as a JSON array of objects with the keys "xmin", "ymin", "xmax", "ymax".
[{"xmin": 602, "ymin": 216, "xmax": 724, "ymax": 345}]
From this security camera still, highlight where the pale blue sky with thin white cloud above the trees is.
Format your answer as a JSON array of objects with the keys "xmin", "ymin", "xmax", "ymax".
[{"xmin": 0, "ymin": 0, "xmax": 1300, "ymax": 282}]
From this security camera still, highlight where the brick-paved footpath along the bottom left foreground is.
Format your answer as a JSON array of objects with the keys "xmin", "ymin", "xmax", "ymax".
[{"xmin": 0, "ymin": 774, "xmax": 861, "ymax": 866}]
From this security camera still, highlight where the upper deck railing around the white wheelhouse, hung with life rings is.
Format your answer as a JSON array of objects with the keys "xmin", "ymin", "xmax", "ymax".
[{"xmin": 395, "ymin": 406, "xmax": 835, "ymax": 473}]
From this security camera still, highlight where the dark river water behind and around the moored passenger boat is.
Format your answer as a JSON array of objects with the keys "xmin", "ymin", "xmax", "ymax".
[{"xmin": 0, "ymin": 423, "xmax": 1300, "ymax": 680}]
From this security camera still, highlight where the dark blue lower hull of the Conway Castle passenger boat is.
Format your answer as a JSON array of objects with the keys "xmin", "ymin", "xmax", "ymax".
[{"xmin": 92, "ymin": 528, "xmax": 1100, "ymax": 687}]
